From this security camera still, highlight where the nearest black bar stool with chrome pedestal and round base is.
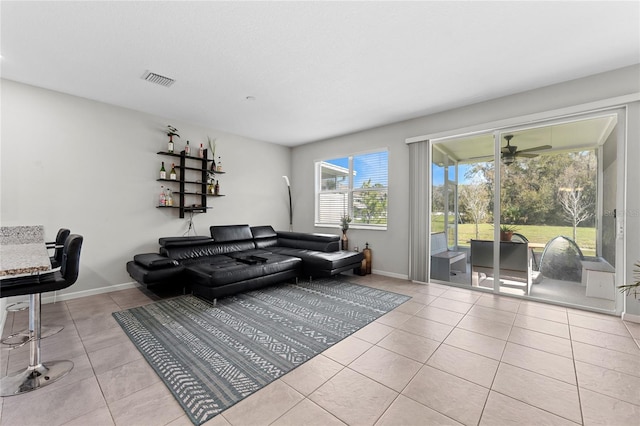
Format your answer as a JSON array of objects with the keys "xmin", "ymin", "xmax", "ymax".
[{"xmin": 0, "ymin": 234, "xmax": 83, "ymax": 396}]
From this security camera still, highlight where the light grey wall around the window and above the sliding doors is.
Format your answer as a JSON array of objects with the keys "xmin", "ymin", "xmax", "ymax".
[{"xmin": 292, "ymin": 65, "xmax": 640, "ymax": 277}]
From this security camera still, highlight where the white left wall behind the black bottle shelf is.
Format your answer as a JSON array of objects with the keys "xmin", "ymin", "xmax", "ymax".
[{"xmin": 0, "ymin": 80, "xmax": 291, "ymax": 297}]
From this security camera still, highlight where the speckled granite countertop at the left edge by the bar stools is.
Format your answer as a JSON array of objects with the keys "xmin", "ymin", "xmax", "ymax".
[{"xmin": 0, "ymin": 225, "xmax": 51, "ymax": 276}]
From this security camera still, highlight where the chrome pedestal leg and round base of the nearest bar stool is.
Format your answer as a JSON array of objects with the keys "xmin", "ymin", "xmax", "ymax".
[{"xmin": 0, "ymin": 293, "xmax": 73, "ymax": 396}]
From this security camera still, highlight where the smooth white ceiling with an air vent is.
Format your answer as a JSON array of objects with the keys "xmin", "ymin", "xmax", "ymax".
[{"xmin": 0, "ymin": 1, "xmax": 640, "ymax": 146}]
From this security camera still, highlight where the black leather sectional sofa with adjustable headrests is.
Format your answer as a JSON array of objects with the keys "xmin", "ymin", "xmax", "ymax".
[{"xmin": 127, "ymin": 225, "xmax": 363, "ymax": 301}]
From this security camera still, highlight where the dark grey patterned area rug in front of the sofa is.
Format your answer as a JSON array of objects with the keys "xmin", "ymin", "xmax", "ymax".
[{"xmin": 113, "ymin": 279, "xmax": 410, "ymax": 425}]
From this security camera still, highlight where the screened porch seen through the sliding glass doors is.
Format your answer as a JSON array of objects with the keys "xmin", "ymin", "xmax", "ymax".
[{"xmin": 429, "ymin": 113, "xmax": 618, "ymax": 311}]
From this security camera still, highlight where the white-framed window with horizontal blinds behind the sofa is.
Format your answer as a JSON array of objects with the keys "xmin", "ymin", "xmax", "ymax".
[{"xmin": 315, "ymin": 150, "xmax": 389, "ymax": 229}]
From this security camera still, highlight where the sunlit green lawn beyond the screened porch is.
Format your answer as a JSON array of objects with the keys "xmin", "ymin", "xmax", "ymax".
[{"xmin": 431, "ymin": 216, "xmax": 596, "ymax": 256}]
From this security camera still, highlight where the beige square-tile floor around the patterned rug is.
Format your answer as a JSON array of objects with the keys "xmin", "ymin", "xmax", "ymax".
[{"xmin": 0, "ymin": 275, "xmax": 640, "ymax": 426}]
